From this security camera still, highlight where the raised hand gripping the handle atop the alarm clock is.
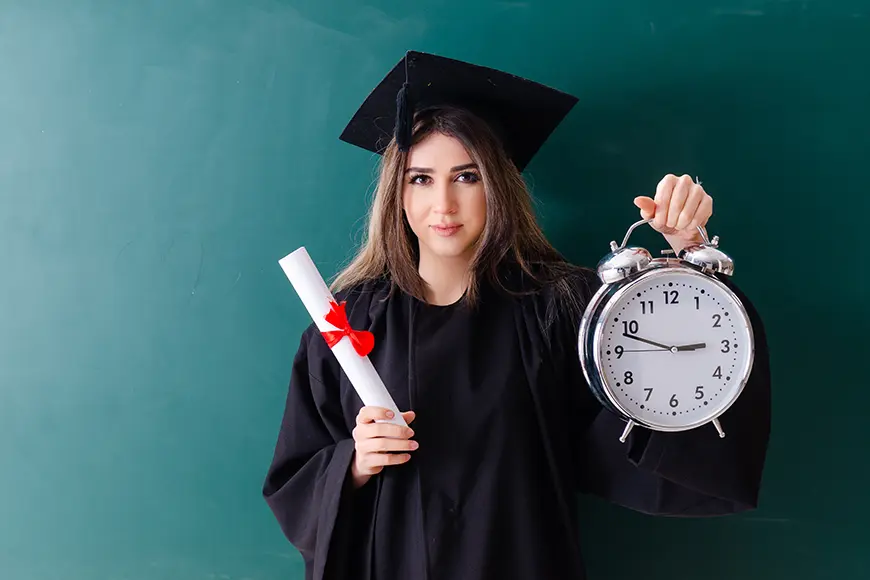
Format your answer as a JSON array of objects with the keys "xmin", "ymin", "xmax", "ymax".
[{"xmin": 634, "ymin": 174, "xmax": 713, "ymax": 253}]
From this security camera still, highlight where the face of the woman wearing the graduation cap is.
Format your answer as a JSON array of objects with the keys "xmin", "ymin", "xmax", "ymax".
[{"xmin": 402, "ymin": 133, "xmax": 486, "ymax": 260}]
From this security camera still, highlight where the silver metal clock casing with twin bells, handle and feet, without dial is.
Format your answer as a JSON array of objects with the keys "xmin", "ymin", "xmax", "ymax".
[{"xmin": 577, "ymin": 220, "xmax": 755, "ymax": 443}]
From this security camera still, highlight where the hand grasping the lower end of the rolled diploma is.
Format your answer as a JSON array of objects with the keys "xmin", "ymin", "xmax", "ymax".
[{"xmin": 351, "ymin": 407, "xmax": 418, "ymax": 488}]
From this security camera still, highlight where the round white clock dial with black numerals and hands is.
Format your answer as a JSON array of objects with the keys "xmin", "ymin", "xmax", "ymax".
[{"xmin": 596, "ymin": 268, "xmax": 753, "ymax": 429}]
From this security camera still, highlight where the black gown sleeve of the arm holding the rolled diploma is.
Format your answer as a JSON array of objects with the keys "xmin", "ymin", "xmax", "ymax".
[{"xmin": 262, "ymin": 325, "xmax": 362, "ymax": 579}]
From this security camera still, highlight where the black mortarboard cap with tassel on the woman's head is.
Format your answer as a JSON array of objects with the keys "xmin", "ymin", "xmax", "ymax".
[{"xmin": 340, "ymin": 51, "xmax": 577, "ymax": 171}]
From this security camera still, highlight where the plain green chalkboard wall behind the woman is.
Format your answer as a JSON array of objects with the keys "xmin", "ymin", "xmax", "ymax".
[{"xmin": 0, "ymin": 0, "xmax": 870, "ymax": 580}]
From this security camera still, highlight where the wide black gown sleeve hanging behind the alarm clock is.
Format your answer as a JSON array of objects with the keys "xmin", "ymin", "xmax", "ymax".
[{"xmin": 563, "ymin": 270, "xmax": 771, "ymax": 517}]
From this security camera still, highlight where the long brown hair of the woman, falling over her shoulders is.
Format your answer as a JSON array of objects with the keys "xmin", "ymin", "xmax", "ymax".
[{"xmin": 331, "ymin": 107, "xmax": 578, "ymax": 312}]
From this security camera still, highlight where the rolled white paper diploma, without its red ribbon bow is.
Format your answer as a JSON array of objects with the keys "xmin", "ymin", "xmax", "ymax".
[{"xmin": 278, "ymin": 247, "xmax": 407, "ymax": 426}]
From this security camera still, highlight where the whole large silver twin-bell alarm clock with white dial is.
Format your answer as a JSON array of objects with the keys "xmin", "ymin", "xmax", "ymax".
[{"xmin": 578, "ymin": 220, "xmax": 755, "ymax": 442}]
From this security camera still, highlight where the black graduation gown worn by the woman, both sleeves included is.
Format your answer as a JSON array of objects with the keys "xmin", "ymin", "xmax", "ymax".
[{"xmin": 263, "ymin": 272, "xmax": 770, "ymax": 580}]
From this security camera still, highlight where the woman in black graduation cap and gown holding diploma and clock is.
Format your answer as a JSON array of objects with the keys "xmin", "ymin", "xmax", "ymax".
[{"xmin": 263, "ymin": 53, "xmax": 770, "ymax": 580}]
